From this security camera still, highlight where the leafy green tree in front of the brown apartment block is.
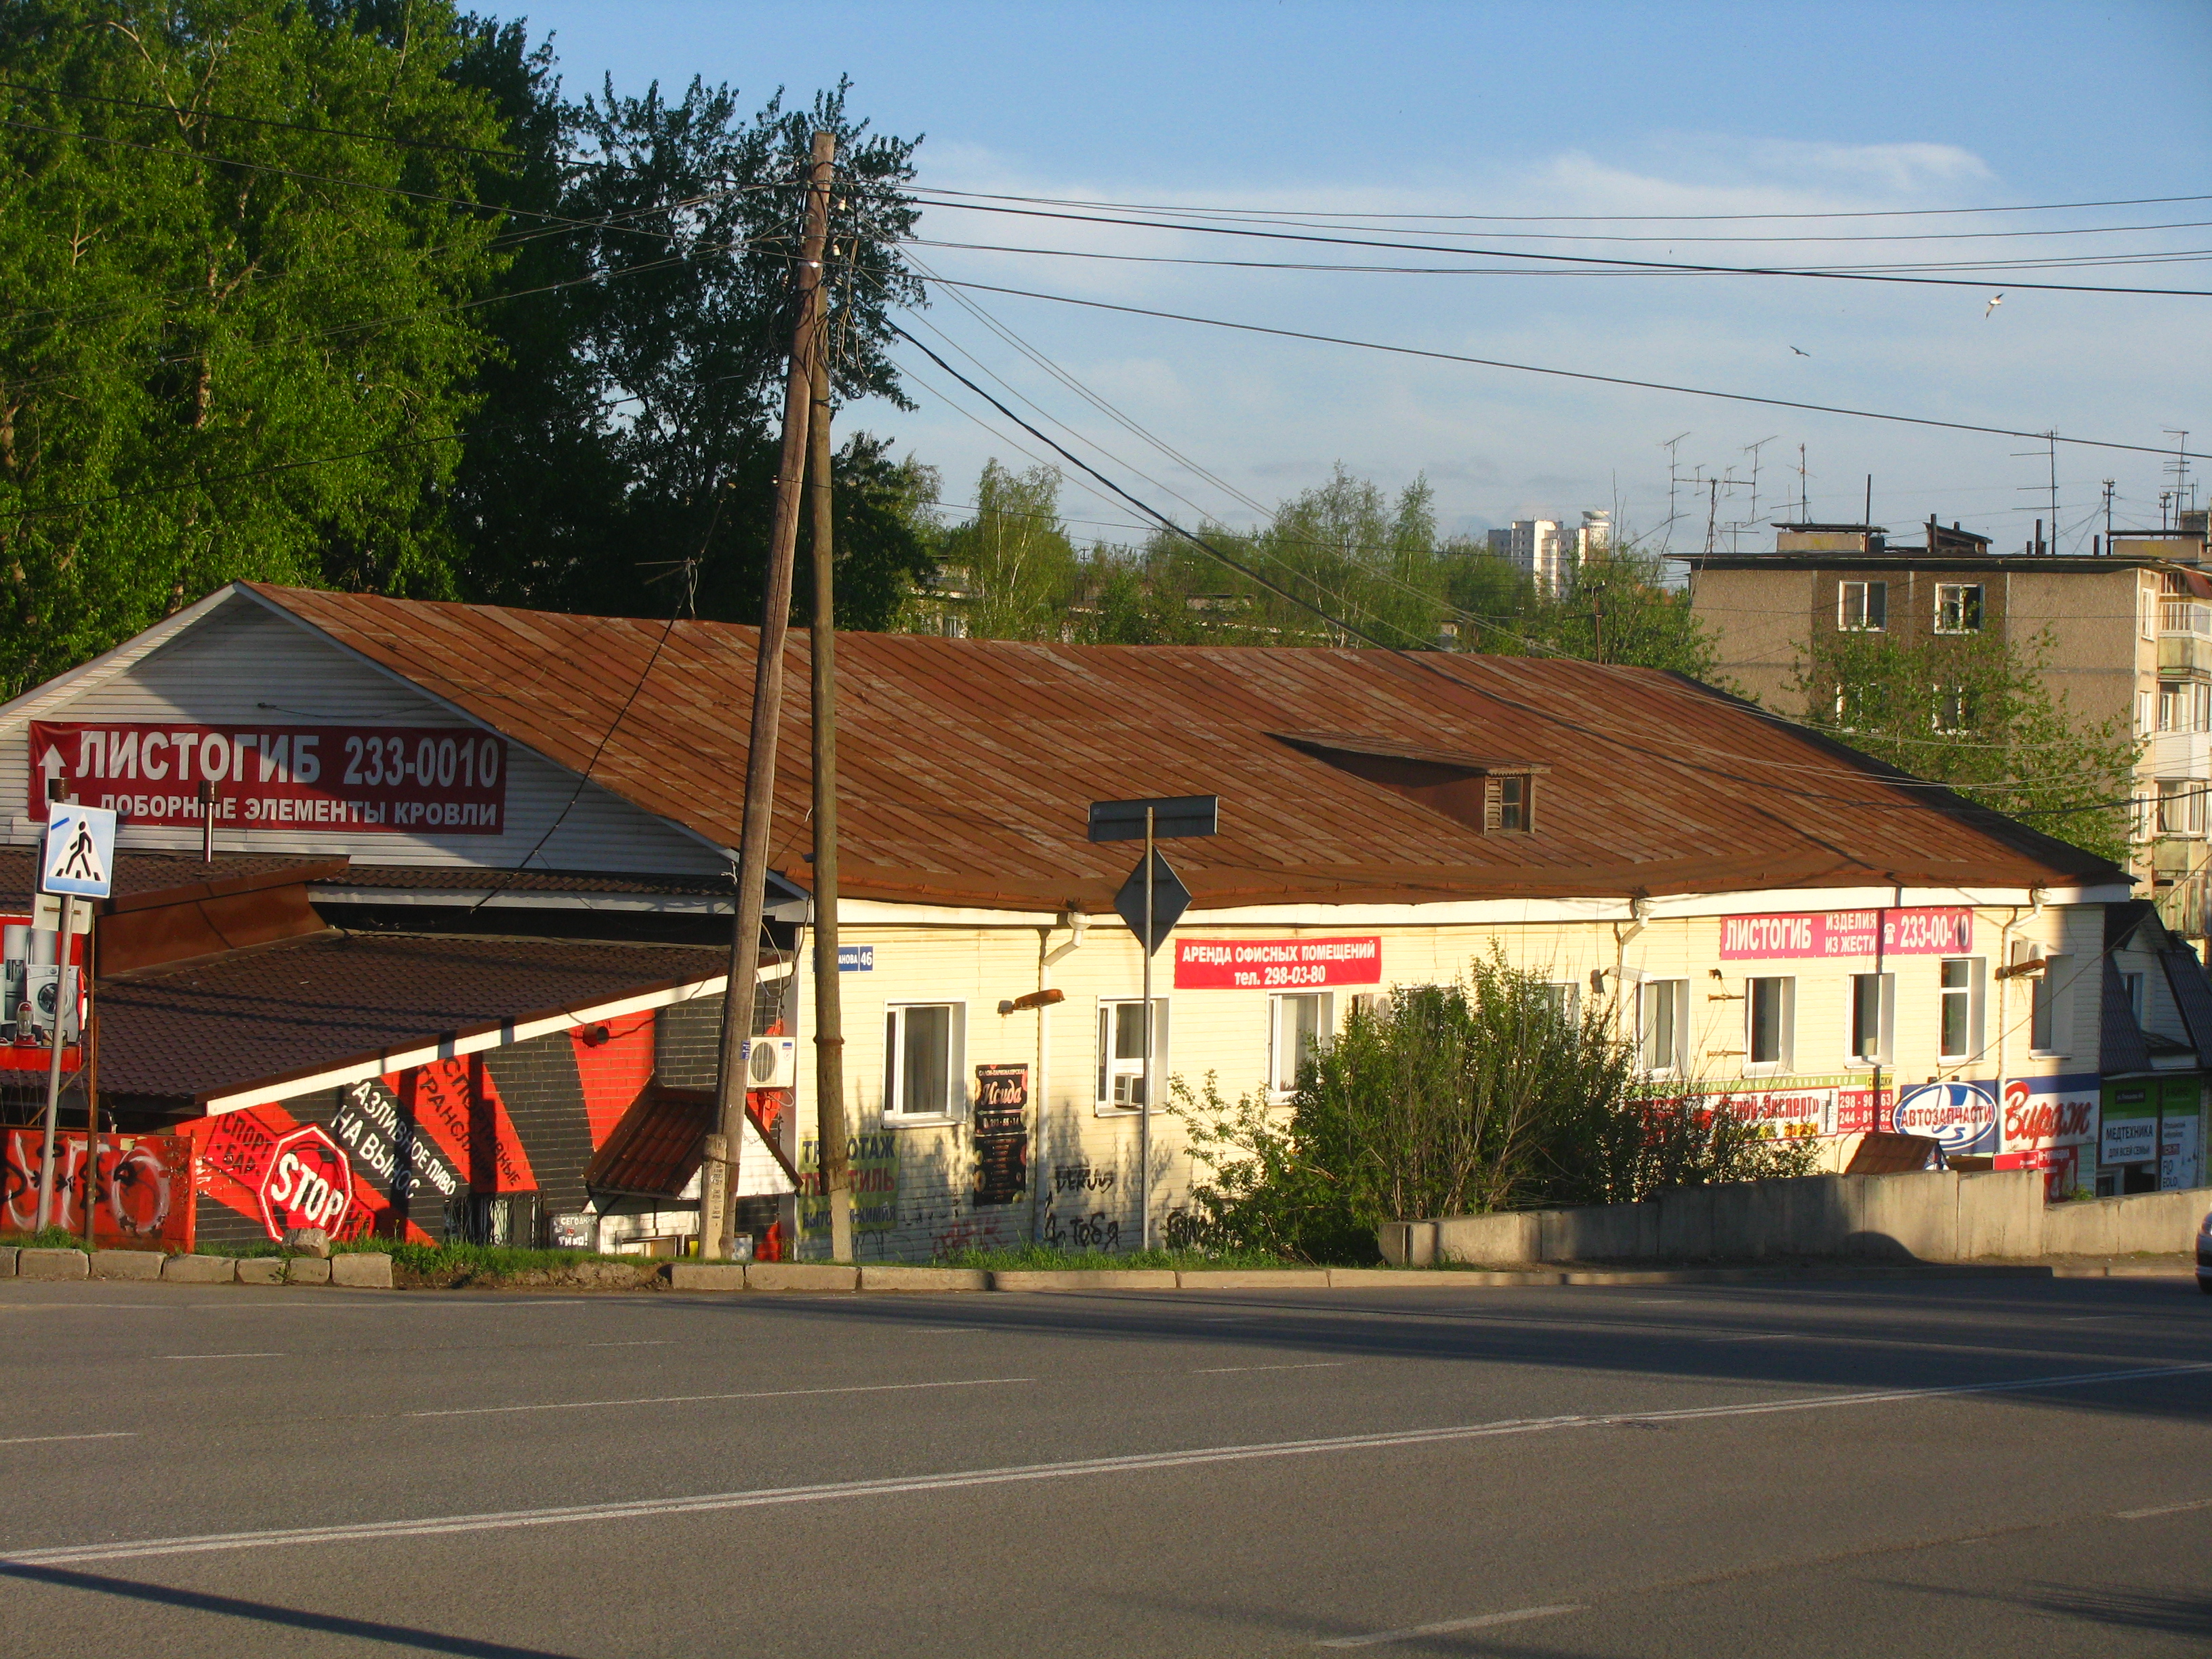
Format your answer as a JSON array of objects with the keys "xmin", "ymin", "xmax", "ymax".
[{"xmin": 1794, "ymin": 630, "xmax": 2142, "ymax": 863}]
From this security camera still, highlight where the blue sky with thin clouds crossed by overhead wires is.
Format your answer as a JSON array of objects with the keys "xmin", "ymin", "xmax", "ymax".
[{"xmin": 508, "ymin": 0, "xmax": 2212, "ymax": 551}]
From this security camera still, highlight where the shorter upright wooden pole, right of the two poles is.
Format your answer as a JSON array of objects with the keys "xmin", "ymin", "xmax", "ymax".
[{"xmin": 807, "ymin": 325, "xmax": 854, "ymax": 1261}]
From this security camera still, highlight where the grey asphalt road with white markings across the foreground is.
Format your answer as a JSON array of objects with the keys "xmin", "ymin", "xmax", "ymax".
[{"xmin": 0, "ymin": 1279, "xmax": 2212, "ymax": 1659}]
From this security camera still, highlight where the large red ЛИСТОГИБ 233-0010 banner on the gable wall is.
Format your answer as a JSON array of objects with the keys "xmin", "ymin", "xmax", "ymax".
[{"xmin": 28, "ymin": 721, "xmax": 506, "ymax": 836}]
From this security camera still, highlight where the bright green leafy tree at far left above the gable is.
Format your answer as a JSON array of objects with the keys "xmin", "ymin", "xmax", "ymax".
[{"xmin": 0, "ymin": 0, "xmax": 504, "ymax": 693}]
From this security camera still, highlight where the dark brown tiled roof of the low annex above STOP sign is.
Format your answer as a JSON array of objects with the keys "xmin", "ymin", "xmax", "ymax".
[{"xmin": 98, "ymin": 933, "xmax": 728, "ymax": 1099}]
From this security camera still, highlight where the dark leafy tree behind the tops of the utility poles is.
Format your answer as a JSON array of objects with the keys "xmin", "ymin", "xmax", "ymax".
[{"xmin": 455, "ymin": 54, "xmax": 929, "ymax": 626}]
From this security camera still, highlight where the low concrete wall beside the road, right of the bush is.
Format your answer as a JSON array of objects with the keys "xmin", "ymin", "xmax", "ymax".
[{"xmin": 1378, "ymin": 1170, "xmax": 2212, "ymax": 1267}]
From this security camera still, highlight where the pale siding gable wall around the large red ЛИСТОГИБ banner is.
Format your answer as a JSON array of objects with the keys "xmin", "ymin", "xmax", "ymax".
[{"xmin": 0, "ymin": 597, "xmax": 728, "ymax": 874}]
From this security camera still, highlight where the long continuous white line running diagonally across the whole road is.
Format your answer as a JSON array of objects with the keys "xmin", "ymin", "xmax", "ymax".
[{"xmin": 0, "ymin": 1360, "xmax": 2212, "ymax": 1566}]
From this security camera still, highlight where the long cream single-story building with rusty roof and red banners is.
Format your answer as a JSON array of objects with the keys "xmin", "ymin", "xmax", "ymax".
[{"xmin": 0, "ymin": 584, "xmax": 2212, "ymax": 1258}]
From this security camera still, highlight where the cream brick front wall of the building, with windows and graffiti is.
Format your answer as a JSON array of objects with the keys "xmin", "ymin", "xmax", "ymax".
[{"xmin": 798, "ymin": 891, "xmax": 2114, "ymax": 1261}]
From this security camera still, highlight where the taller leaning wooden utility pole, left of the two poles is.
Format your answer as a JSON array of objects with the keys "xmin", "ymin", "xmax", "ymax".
[{"xmin": 699, "ymin": 133, "xmax": 836, "ymax": 1256}]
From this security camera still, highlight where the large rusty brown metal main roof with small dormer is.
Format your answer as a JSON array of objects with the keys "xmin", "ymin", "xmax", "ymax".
[{"xmin": 254, "ymin": 586, "xmax": 2123, "ymax": 912}]
